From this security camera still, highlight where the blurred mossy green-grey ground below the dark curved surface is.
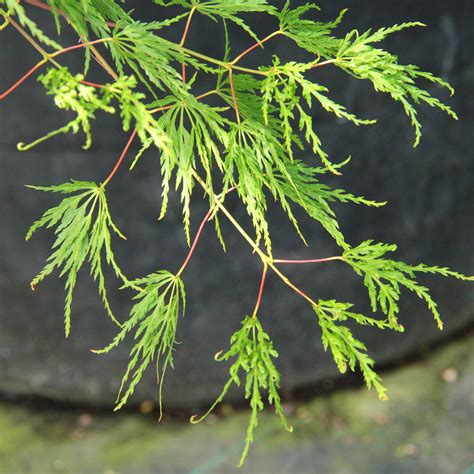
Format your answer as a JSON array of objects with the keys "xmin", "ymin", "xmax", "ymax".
[{"xmin": 0, "ymin": 334, "xmax": 474, "ymax": 474}]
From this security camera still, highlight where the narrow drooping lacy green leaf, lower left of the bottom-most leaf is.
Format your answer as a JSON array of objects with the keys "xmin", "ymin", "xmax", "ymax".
[{"xmin": 93, "ymin": 271, "xmax": 186, "ymax": 412}]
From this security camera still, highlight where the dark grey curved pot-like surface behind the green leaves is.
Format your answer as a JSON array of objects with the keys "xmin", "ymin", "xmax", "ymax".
[{"xmin": 0, "ymin": 0, "xmax": 474, "ymax": 407}]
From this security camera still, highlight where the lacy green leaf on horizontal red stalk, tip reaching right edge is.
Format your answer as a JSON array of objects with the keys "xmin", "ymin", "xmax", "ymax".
[{"xmin": 343, "ymin": 240, "xmax": 472, "ymax": 329}]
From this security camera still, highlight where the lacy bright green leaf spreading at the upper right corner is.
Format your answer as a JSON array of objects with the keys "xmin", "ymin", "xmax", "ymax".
[{"xmin": 335, "ymin": 22, "xmax": 457, "ymax": 146}]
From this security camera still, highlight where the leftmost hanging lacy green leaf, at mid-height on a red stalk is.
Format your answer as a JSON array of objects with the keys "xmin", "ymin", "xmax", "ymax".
[{"xmin": 26, "ymin": 181, "xmax": 126, "ymax": 336}]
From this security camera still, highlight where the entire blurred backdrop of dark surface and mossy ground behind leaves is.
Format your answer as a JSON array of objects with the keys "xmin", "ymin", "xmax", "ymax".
[{"xmin": 0, "ymin": 0, "xmax": 474, "ymax": 474}]
